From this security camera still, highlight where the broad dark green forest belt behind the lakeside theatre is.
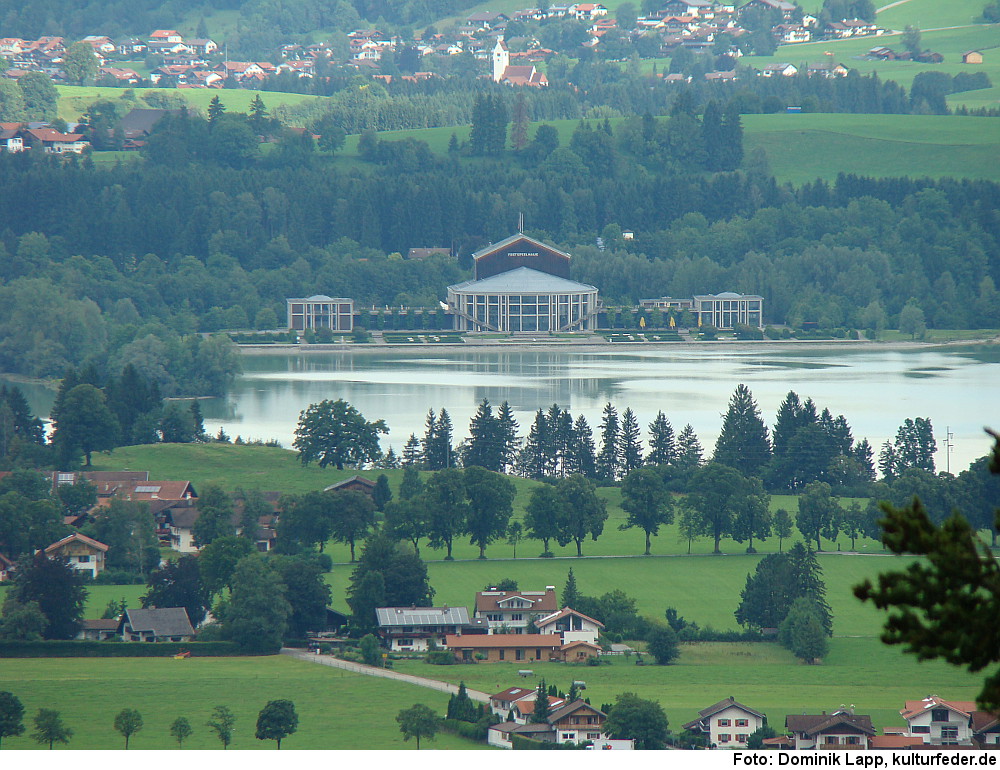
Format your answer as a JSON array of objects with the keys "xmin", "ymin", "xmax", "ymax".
[{"xmin": 0, "ymin": 100, "xmax": 1000, "ymax": 382}]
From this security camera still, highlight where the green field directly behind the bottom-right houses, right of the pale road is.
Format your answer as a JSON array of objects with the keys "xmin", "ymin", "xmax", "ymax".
[{"xmin": 395, "ymin": 639, "xmax": 981, "ymax": 732}]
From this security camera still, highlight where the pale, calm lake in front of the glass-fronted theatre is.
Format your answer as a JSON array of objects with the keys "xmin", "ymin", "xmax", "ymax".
[{"xmin": 202, "ymin": 344, "xmax": 1000, "ymax": 472}]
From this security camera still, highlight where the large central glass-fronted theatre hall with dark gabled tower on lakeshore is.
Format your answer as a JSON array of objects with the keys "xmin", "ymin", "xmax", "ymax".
[{"xmin": 448, "ymin": 233, "xmax": 598, "ymax": 332}]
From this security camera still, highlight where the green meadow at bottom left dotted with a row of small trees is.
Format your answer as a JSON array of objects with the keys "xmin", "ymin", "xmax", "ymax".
[{"xmin": 0, "ymin": 655, "xmax": 485, "ymax": 750}]
